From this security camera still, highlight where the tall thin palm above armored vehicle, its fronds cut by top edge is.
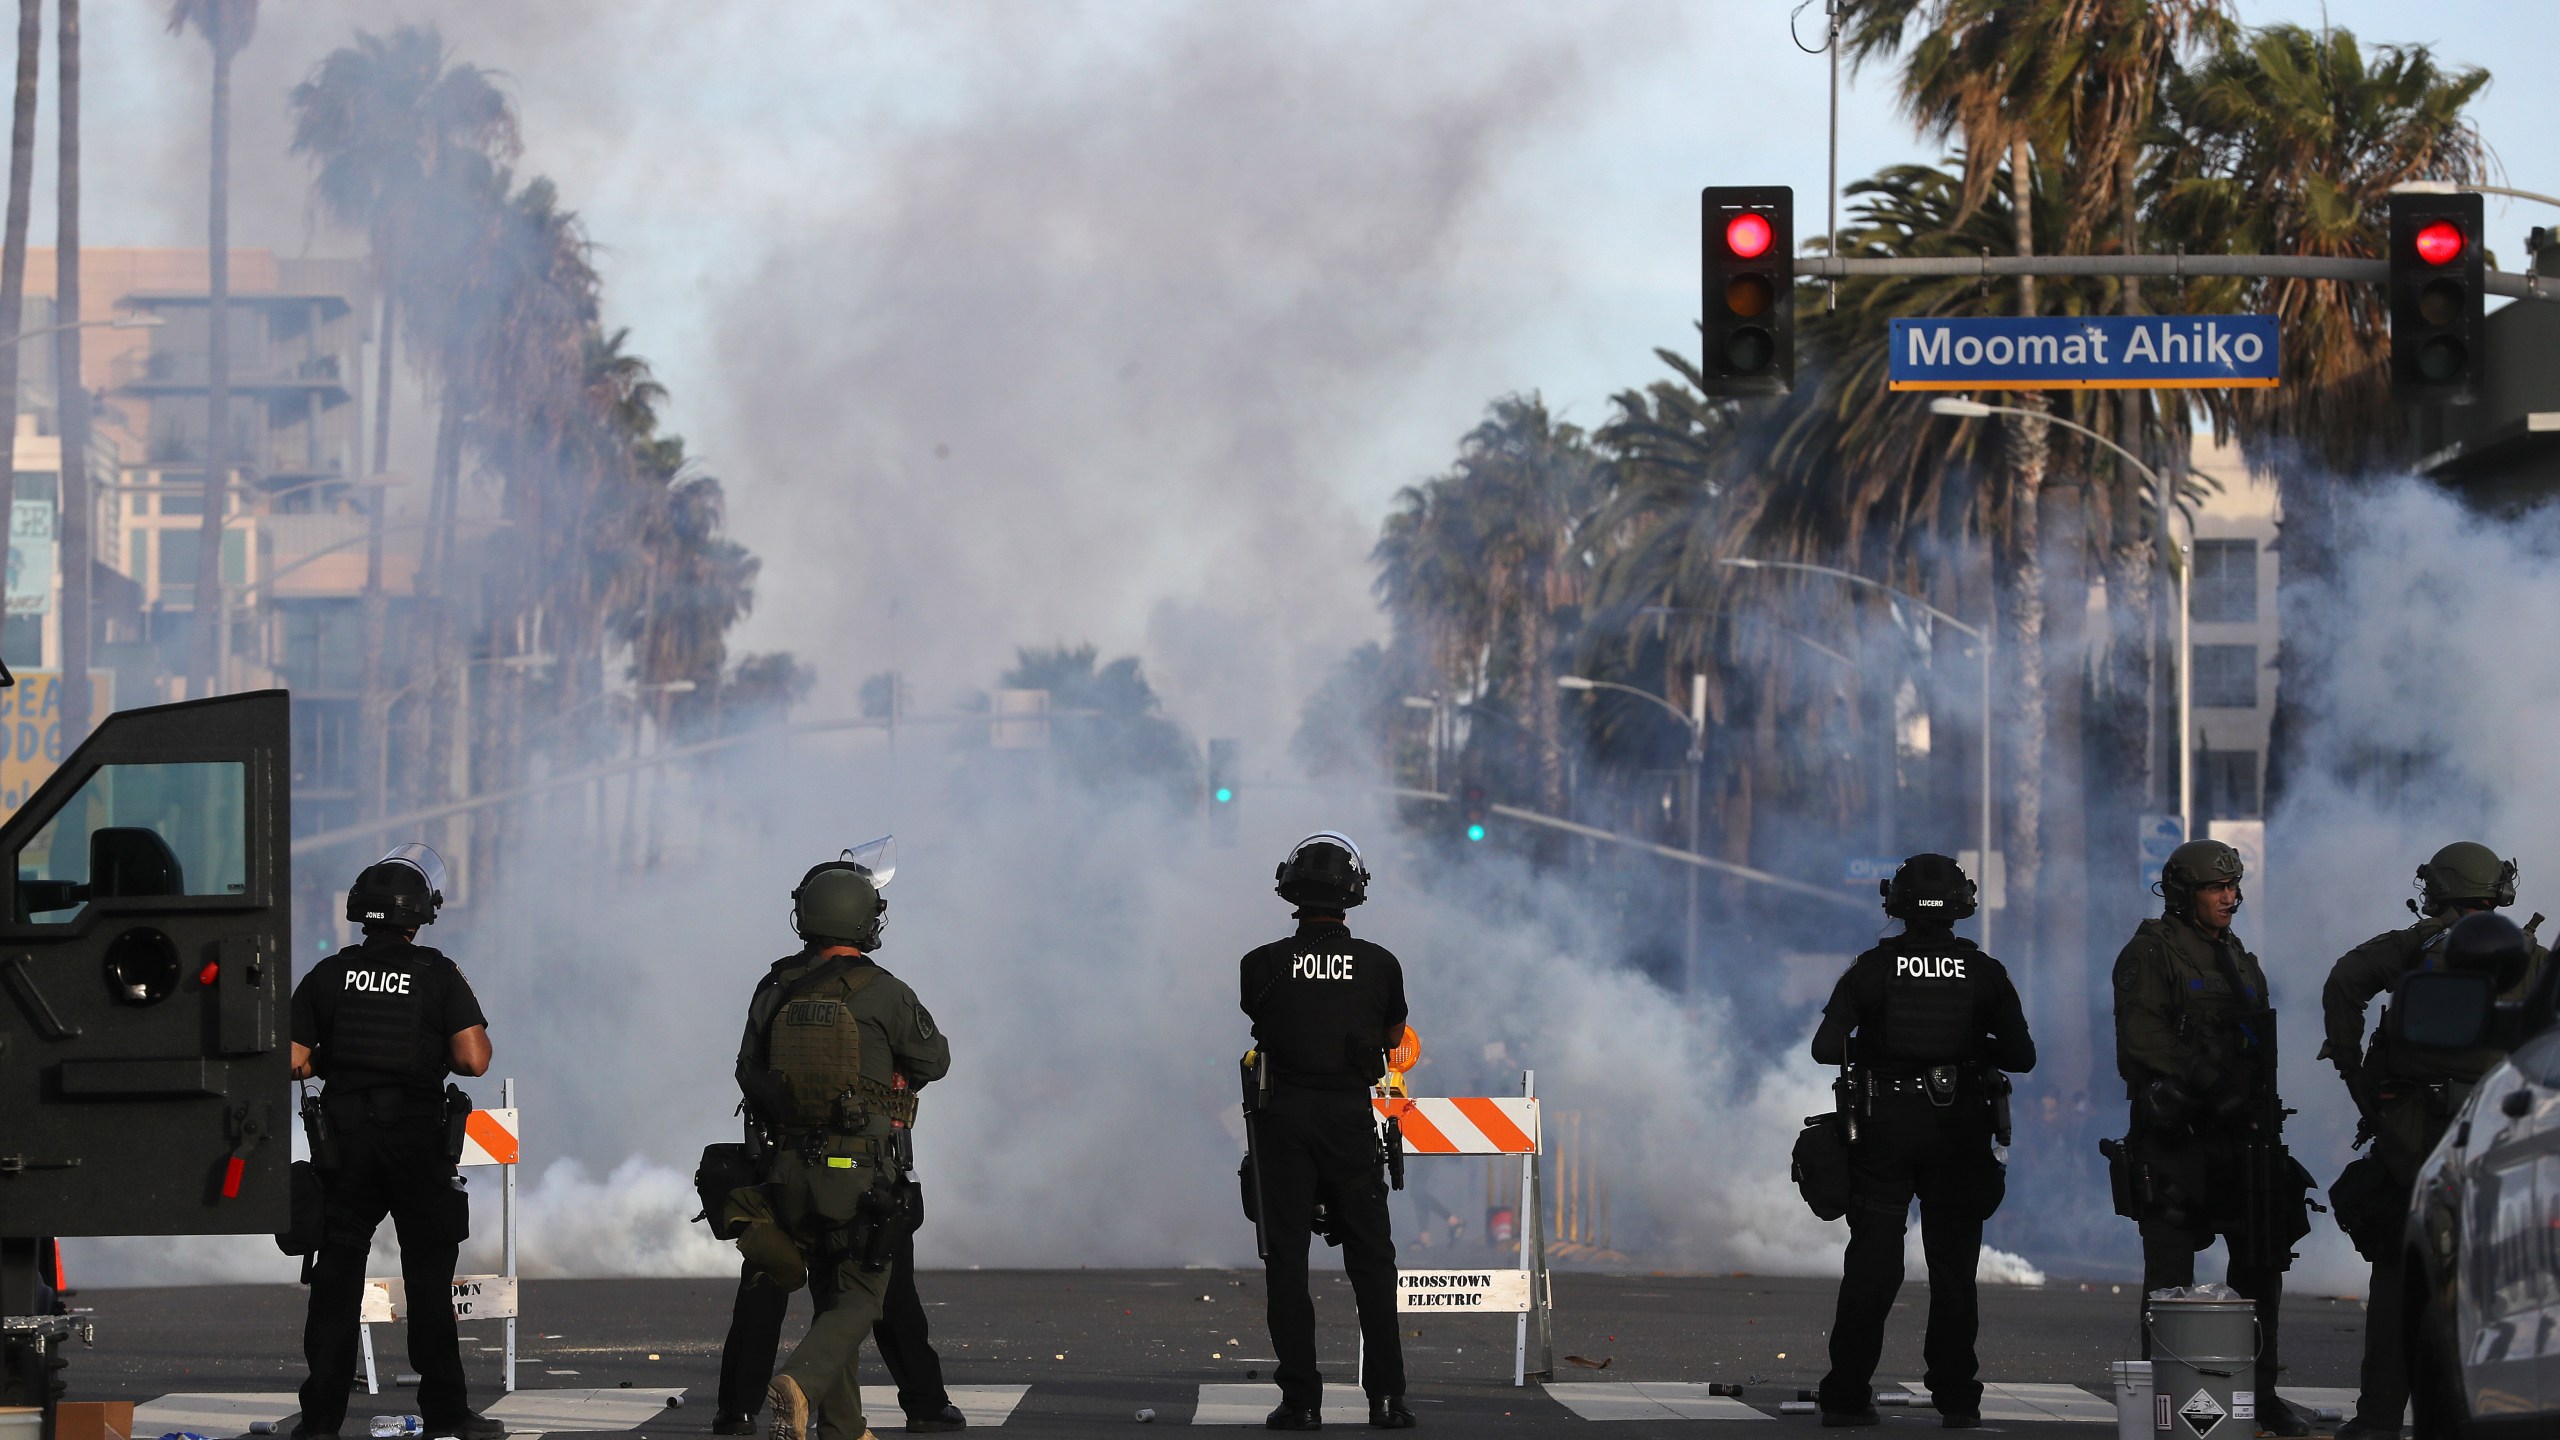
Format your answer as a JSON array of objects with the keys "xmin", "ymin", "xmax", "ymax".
[{"xmin": 169, "ymin": 0, "xmax": 259, "ymax": 694}]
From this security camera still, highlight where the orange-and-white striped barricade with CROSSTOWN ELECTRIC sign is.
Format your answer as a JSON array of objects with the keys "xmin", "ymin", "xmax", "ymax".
[{"xmin": 1370, "ymin": 1071, "xmax": 1556, "ymax": 1386}]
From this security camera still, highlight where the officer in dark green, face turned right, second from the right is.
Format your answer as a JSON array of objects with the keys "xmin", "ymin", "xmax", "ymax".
[{"xmin": 2104, "ymin": 840, "xmax": 2312, "ymax": 1435}]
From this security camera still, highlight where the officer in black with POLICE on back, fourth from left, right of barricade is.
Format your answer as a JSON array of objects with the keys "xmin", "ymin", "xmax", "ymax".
[{"xmin": 1812, "ymin": 856, "xmax": 2035, "ymax": 1430}]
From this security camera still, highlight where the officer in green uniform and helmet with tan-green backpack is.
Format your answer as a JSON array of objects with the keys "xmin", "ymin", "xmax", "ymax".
[{"xmin": 727, "ymin": 861, "xmax": 950, "ymax": 1440}]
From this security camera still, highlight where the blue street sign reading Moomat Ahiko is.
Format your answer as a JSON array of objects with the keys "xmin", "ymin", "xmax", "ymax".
[{"xmin": 1887, "ymin": 315, "xmax": 2276, "ymax": 389}]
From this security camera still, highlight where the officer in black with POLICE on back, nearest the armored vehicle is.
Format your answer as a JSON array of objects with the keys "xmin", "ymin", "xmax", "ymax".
[{"xmin": 292, "ymin": 846, "xmax": 507, "ymax": 1440}]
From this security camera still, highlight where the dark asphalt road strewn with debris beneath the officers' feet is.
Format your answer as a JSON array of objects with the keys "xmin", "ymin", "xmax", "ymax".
[{"xmin": 69, "ymin": 1271, "xmax": 2363, "ymax": 1440}]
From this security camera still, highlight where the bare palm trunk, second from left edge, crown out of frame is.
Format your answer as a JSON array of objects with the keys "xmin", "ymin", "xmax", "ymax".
[{"xmin": 54, "ymin": 0, "xmax": 95, "ymax": 746}]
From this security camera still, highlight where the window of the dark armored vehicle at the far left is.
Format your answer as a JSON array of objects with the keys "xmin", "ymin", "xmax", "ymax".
[{"xmin": 13, "ymin": 764, "xmax": 248, "ymax": 922}]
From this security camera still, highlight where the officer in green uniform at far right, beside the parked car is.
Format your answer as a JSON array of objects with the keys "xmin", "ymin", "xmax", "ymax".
[{"xmin": 2319, "ymin": 840, "xmax": 2542, "ymax": 1440}]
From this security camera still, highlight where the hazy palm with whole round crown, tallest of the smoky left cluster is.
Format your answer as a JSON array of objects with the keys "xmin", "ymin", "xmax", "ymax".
[{"xmin": 292, "ymin": 26, "xmax": 520, "ymax": 812}]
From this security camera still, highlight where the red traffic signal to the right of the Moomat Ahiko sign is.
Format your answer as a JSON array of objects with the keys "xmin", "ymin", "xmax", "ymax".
[{"xmin": 2388, "ymin": 195, "xmax": 2488, "ymax": 405}]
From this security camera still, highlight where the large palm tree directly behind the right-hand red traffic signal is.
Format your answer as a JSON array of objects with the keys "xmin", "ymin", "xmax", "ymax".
[{"xmin": 2158, "ymin": 26, "xmax": 2488, "ymax": 802}]
